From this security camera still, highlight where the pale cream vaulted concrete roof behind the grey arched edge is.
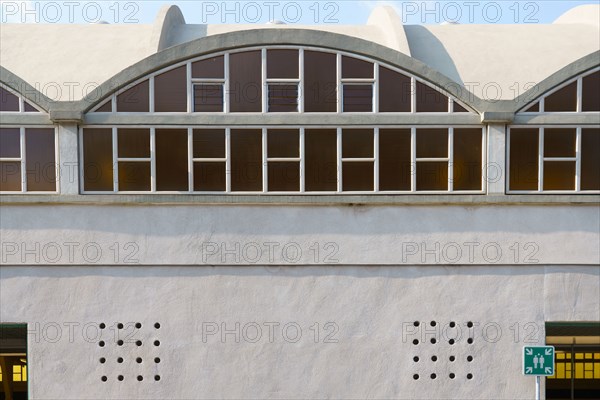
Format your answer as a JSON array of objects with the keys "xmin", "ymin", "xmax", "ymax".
[{"xmin": 0, "ymin": 5, "xmax": 600, "ymax": 101}]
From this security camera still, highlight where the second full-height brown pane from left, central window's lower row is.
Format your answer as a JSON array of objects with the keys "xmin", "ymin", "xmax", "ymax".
[{"xmin": 155, "ymin": 129, "xmax": 189, "ymax": 192}]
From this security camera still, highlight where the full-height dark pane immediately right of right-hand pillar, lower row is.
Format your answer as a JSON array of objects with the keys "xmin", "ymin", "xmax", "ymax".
[{"xmin": 509, "ymin": 128, "xmax": 539, "ymax": 190}]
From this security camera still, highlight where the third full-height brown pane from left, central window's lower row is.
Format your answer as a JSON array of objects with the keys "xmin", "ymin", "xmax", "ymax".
[{"xmin": 231, "ymin": 129, "xmax": 262, "ymax": 192}]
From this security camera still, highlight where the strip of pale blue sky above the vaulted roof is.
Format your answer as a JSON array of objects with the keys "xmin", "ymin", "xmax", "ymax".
[{"xmin": 0, "ymin": 0, "xmax": 600, "ymax": 24}]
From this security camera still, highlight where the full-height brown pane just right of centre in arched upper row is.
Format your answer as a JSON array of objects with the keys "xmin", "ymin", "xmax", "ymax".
[{"xmin": 304, "ymin": 51, "xmax": 337, "ymax": 112}]
